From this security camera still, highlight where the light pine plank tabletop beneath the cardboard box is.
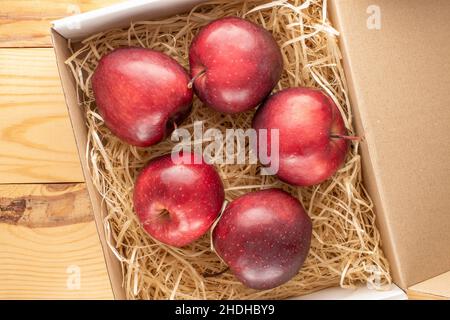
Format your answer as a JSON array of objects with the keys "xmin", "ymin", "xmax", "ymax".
[{"xmin": 0, "ymin": 0, "xmax": 432, "ymax": 299}]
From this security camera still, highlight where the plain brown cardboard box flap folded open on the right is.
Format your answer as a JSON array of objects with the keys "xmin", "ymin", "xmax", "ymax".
[{"xmin": 330, "ymin": 0, "xmax": 450, "ymax": 288}]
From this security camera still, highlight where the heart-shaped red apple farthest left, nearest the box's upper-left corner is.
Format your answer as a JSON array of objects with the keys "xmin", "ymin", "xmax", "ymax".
[{"xmin": 92, "ymin": 47, "xmax": 193, "ymax": 147}]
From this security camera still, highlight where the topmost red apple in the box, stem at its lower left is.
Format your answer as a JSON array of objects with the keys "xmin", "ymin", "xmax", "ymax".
[{"xmin": 189, "ymin": 17, "xmax": 283, "ymax": 114}]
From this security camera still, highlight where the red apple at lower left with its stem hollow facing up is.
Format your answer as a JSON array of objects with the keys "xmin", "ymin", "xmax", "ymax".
[{"xmin": 133, "ymin": 153, "xmax": 224, "ymax": 247}]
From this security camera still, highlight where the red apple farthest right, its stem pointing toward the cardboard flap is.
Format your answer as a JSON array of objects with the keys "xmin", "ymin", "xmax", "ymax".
[{"xmin": 253, "ymin": 88, "xmax": 351, "ymax": 186}]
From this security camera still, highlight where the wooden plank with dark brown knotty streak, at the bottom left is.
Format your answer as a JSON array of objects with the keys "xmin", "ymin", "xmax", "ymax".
[{"xmin": 0, "ymin": 184, "xmax": 113, "ymax": 299}]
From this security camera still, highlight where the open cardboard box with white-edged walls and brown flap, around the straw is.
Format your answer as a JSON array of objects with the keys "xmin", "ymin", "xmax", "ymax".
[{"xmin": 52, "ymin": 0, "xmax": 450, "ymax": 299}]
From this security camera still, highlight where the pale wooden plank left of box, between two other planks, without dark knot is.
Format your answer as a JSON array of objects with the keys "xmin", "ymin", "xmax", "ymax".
[{"xmin": 0, "ymin": 48, "xmax": 84, "ymax": 183}]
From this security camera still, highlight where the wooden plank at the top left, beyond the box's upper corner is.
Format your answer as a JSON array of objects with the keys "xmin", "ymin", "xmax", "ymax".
[{"xmin": 0, "ymin": 0, "xmax": 123, "ymax": 47}]
